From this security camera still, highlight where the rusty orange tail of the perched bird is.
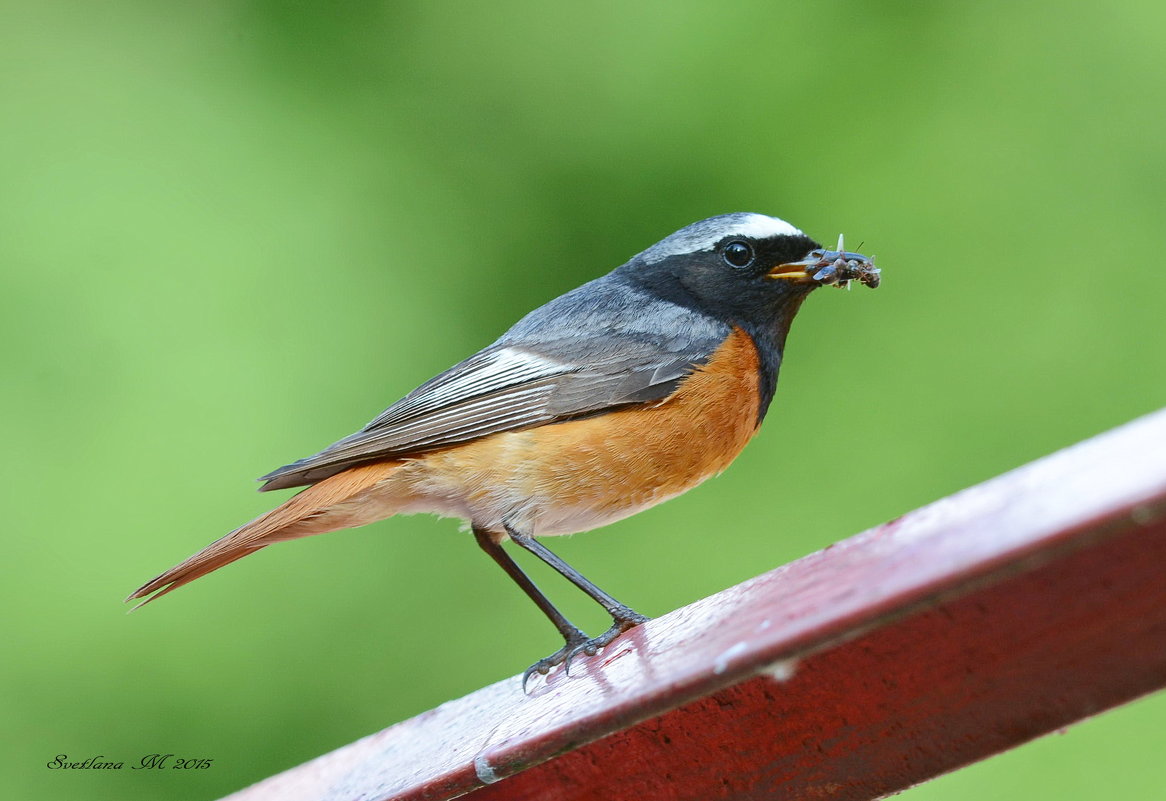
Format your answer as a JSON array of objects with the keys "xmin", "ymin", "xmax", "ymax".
[{"xmin": 126, "ymin": 462, "xmax": 402, "ymax": 611}]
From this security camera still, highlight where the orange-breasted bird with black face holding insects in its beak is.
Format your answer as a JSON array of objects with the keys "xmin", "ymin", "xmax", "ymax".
[{"xmin": 127, "ymin": 213, "xmax": 879, "ymax": 684}]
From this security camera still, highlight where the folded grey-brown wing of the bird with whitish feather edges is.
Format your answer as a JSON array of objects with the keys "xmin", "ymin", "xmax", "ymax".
[{"xmin": 260, "ymin": 333, "xmax": 719, "ymax": 490}]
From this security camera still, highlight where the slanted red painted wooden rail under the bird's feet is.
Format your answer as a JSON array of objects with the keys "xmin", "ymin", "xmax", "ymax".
[{"xmin": 230, "ymin": 410, "xmax": 1166, "ymax": 801}]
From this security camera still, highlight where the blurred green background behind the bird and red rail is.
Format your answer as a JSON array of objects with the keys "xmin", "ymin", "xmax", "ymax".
[{"xmin": 0, "ymin": 0, "xmax": 1166, "ymax": 801}]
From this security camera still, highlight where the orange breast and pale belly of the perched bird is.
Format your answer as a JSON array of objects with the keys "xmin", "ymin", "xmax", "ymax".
[{"xmin": 401, "ymin": 329, "xmax": 759, "ymax": 535}]
